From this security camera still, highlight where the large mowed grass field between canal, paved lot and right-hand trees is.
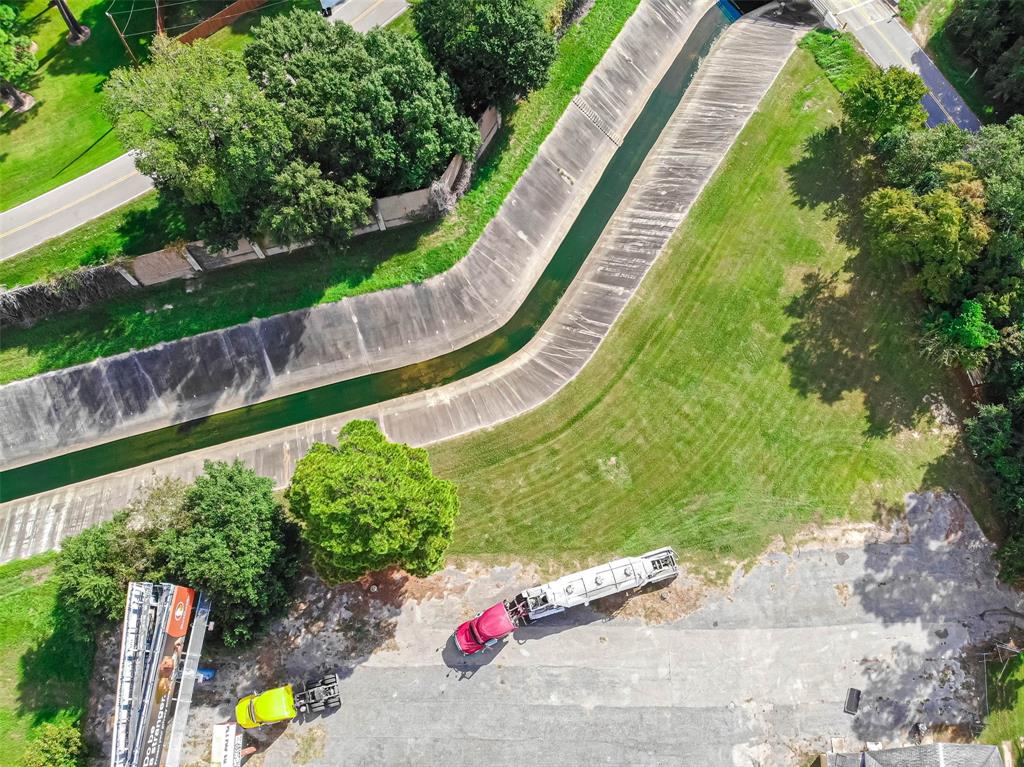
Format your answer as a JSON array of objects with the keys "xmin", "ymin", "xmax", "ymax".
[{"xmin": 431, "ymin": 50, "xmax": 976, "ymax": 578}]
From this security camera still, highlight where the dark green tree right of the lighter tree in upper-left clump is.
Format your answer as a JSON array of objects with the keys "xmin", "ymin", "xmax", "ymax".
[{"xmin": 245, "ymin": 10, "xmax": 479, "ymax": 195}]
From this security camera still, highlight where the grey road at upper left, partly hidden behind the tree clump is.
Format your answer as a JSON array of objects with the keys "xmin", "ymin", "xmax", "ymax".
[{"xmin": 0, "ymin": 0, "xmax": 409, "ymax": 260}]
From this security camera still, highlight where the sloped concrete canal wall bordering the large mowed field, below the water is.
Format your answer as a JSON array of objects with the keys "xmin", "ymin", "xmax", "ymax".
[{"xmin": 0, "ymin": 10, "xmax": 804, "ymax": 561}]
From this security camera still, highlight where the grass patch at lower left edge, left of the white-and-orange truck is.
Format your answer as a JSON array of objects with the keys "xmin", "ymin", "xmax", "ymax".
[{"xmin": 0, "ymin": 555, "xmax": 93, "ymax": 767}]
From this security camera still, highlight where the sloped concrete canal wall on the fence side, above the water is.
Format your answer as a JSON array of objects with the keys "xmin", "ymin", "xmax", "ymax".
[{"xmin": 0, "ymin": 0, "xmax": 713, "ymax": 469}]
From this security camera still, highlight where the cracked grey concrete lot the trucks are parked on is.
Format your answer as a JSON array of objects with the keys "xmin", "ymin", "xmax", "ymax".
[{"xmin": 81, "ymin": 494, "xmax": 1024, "ymax": 767}]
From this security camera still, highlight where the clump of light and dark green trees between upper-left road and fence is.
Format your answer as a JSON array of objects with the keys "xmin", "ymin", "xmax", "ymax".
[{"xmin": 105, "ymin": 10, "xmax": 479, "ymax": 247}]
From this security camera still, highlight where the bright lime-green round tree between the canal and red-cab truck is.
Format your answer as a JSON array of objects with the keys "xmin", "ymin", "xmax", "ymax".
[{"xmin": 288, "ymin": 421, "xmax": 459, "ymax": 582}]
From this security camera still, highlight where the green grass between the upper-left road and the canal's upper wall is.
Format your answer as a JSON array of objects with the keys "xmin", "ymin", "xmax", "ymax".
[{"xmin": 0, "ymin": 0, "xmax": 638, "ymax": 383}]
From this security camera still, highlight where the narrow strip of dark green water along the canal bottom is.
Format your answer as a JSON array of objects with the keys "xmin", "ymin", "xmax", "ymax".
[{"xmin": 0, "ymin": 5, "xmax": 729, "ymax": 501}]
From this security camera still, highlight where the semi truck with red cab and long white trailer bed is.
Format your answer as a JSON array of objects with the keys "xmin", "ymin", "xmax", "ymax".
[{"xmin": 455, "ymin": 546, "xmax": 679, "ymax": 655}]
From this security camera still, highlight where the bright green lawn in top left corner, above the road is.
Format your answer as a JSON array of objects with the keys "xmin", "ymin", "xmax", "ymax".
[{"xmin": 0, "ymin": 0, "xmax": 140, "ymax": 210}]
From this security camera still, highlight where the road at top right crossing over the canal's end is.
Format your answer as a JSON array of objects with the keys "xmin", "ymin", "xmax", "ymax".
[{"xmin": 818, "ymin": 0, "xmax": 981, "ymax": 131}]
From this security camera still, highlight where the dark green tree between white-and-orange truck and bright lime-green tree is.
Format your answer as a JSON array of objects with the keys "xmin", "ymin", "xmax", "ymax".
[{"xmin": 158, "ymin": 461, "xmax": 292, "ymax": 645}]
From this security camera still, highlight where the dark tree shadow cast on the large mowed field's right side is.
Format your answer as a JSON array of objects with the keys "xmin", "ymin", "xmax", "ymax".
[{"xmin": 783, "ymin": 128, "xmax": 962, "ymax": 437}]
